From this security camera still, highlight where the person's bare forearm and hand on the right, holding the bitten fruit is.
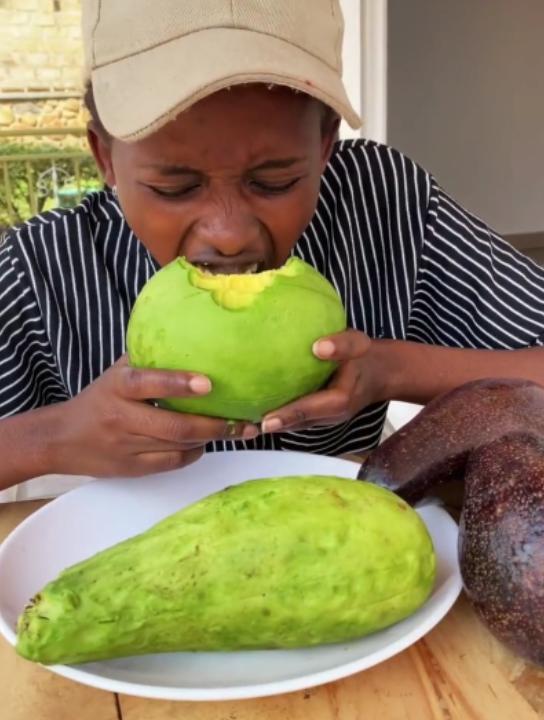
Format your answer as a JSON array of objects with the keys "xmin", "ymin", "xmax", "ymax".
[{"xmin": 262, "ymin": 330, "xmax": 544, "ymax": 432}]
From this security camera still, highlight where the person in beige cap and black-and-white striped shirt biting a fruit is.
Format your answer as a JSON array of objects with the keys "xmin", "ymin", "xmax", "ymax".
[{"xmin": 0, "ymin": 0, "xmax": 544, "ymax": 487}]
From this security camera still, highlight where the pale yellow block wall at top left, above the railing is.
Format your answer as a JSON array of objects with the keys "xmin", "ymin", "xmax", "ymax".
[{"xmin": 0, "ymin": 0, "xmax": 82, "ymax": 94}]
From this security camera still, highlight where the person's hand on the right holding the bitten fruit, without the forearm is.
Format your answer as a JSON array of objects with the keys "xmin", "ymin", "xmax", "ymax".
[{"xmin": 262, "ymin": 330, "xmax": 382, "ymax": 433}]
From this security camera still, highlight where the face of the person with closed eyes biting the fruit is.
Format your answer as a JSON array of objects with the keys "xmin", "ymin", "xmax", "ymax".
[{"xmin": 90, "ymin": 85, "xmax": 336, "ymax": 272}]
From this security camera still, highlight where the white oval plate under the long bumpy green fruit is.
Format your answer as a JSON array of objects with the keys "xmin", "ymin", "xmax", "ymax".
[{"xmin": 0, "ymin": 451, "xmax": 461, "ymax": 701}]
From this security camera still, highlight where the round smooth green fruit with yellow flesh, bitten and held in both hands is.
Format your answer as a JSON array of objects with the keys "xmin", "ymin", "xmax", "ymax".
[{"xmin": 127, "ymin": 258, "xmax": 346, "ymax": 423}]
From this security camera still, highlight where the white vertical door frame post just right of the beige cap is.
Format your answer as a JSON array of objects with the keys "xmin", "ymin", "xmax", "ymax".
[{"xmin": 340, "ymin": 0, "xmax": 387, "ymax": 142}]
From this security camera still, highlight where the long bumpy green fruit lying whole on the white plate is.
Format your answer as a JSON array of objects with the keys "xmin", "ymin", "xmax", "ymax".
[{"xmin": 16, "ymin": 476, "xmax": 436, "ymax": 665}]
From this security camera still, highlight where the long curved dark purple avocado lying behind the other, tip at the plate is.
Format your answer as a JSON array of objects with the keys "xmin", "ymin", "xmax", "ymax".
[{"xmin": 358, "ymin": 378, "xmax": 544, "ymax": 505}]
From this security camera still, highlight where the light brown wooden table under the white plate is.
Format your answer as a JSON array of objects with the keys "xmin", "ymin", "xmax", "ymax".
[{"xmin": 0, "ymin": 502, "xmax": 544, "ymax": 720}]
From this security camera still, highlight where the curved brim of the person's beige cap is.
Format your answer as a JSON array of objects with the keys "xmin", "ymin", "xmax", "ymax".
[{"xmin": 92, "ymin": 28, "xmax": 361, "ymax": 142}]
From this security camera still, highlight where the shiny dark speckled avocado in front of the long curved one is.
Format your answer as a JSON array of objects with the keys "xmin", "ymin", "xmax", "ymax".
[{"xmin": 459, "ymin": 432, "xmax": 544, "ymax": 667}]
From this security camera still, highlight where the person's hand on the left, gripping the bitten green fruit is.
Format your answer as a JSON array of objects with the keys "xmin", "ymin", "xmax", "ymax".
[{"xmin": 51, "ymin": 356, "xmax": 258, "ymax": 478}]
